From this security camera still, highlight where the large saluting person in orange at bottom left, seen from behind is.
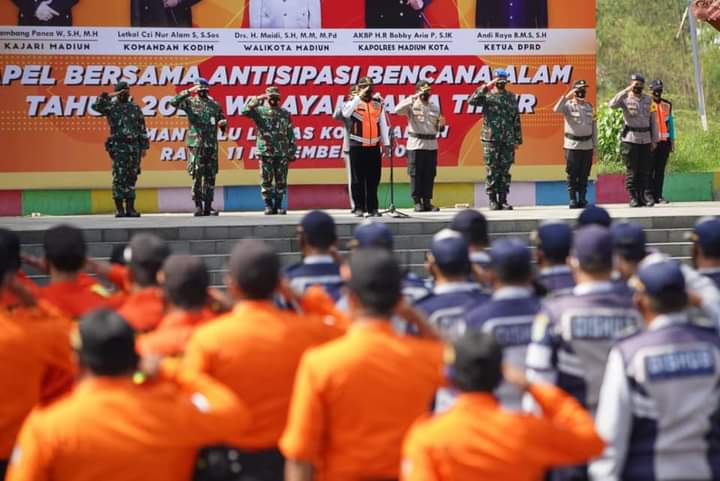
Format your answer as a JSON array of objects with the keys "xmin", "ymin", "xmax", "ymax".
[{"xmin": 7, "ymin": 310, "xmax": 249, "ymax": 481}]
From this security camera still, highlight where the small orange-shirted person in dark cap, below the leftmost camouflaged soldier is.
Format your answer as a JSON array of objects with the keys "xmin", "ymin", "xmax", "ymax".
[{"xmin": 117, "ymin": 233, "xmax": 170, "ymax": 332}]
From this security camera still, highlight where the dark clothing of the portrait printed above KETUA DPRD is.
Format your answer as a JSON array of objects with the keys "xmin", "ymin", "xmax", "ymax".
[{"xmin": 475, "ymin": 0, "xmax": 548, "ymax": 28}]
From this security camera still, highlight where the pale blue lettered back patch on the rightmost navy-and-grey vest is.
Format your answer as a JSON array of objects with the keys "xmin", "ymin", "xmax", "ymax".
[{"xmin": 645, "ymin": 350, "xmax": 715, "ymax": 381}]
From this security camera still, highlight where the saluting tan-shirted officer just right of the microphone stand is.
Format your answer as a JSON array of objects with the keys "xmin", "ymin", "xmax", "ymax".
[{"xmin": 395, "ymin": 81, "xmax": 446, "ymax": 212}]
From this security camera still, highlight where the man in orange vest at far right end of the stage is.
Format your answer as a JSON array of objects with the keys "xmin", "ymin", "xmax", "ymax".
[{"xmin": 648, "ymin": 80, "xmax": 675, "ymax": 204}]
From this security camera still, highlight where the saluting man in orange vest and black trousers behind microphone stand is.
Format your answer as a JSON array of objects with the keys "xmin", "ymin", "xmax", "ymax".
[{"xmin": 342, "ymin": 77, "xmax": 391, "ymax": 217}]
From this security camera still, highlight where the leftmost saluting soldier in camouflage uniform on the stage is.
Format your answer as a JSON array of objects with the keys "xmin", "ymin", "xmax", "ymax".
[{"xmin": 92, "ymin": 82, "xmax": 150, "ymax": 217}]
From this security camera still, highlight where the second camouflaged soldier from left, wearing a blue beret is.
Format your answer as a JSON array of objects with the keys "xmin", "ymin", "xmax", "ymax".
[{"xmin": 171, "ymin": 78, "xmax": 227, "ymax": 217}]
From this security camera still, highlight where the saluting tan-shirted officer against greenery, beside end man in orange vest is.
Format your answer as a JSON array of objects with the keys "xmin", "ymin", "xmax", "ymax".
[{"xmin": 608, "ymin": 74, "xmax": 659, "ymax": 207}]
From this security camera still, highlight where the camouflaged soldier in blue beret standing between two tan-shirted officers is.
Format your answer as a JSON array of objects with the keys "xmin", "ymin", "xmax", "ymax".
[{"xmin": 469, "ymin": 69, "xmax": 522, "ymax": 210}]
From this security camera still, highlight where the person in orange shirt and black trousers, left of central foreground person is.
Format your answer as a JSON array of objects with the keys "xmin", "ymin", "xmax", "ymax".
[{"xmin": 184, "ymin": 240, "xmax": 344, "ymax": 481}]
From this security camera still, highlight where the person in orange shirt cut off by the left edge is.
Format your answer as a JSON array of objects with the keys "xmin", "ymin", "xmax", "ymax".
[{"xmin": 0, "ymin": 246, "xmax": 75, "ymax": 480}]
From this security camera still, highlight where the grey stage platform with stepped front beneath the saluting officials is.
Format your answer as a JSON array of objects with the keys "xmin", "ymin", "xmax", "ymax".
[{"xmin": 0, "ymin": 202, "xmax": 720, "ymax": 285}]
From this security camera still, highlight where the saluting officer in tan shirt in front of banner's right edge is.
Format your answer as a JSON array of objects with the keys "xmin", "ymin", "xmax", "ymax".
[{"xmin": 554, "ymin": 80, "xmax": 597, "ymax": 209}]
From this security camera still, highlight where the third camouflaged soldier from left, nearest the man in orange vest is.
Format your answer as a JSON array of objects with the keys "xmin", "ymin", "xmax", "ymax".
[{"xmin": 242, "ymin": 87, "xmax": 296, "ymax": 215}]
